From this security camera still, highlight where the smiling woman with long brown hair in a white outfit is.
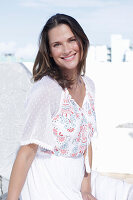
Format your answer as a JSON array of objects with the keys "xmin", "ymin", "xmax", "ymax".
[{"xmin": 7, "ymin": 14, "xmax": 96, "ymax": 200}]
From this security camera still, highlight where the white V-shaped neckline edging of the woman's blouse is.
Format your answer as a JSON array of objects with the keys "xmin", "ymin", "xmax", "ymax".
[{"xmin": 65, "ymin": 77, "xmax": 88, "ymax": 110}]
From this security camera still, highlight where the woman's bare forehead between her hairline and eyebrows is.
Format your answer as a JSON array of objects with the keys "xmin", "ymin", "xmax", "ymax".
[{"xmin": 48, "ymin": 24, "xmax": 74, "ymax": 43}]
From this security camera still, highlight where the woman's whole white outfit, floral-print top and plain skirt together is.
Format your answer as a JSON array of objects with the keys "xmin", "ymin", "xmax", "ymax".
[{"xmin": 20, "ymin": 76, "xmax": 96, "ymax": 200}]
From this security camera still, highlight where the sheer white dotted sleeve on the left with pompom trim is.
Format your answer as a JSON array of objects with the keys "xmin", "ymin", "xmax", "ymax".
[{"xmin": 20, "ymin": 76, "xmax": 60, "ymax": 151}]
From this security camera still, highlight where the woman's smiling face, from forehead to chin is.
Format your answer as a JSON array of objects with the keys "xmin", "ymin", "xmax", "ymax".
[{"xmin": 48, "ymin": 24, "xmax": 80, "ymax": 71}]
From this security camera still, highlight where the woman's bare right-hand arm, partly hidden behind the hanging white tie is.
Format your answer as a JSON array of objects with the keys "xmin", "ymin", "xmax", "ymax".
[{"xmin": 81, "ymin": 143, "xmax": 96, "ymax": 200}]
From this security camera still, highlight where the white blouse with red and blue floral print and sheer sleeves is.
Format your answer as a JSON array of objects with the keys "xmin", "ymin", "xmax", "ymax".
[{"xmin": 21, "ymin": 76, "xmax": 96, "ymax": 157}]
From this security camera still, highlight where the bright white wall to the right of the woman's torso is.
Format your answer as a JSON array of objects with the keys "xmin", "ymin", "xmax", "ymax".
[{"xmin": 87, "ymin": 63, "xmax": 133, "ymax": 173}]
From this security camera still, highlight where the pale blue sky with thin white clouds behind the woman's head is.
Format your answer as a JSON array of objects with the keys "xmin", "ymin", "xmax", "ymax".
[{"xmin": 0, "ymin": 0, "xmax": 133, "ymax": 57}]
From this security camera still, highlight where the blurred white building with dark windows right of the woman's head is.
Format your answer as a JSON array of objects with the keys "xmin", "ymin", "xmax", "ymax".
[{"xmin": 87, "ymin": 34, "xmax": 133, "ymax": 63}]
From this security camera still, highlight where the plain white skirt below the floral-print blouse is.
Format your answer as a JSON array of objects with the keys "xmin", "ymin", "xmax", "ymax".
[{"xmin": 20, "ymin": 153, "xmax": 85, "ymax": 200}]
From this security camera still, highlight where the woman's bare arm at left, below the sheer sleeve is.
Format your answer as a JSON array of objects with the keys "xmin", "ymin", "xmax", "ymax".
[{"xmin": 7, "ymin": 144, "xmax": 38, "ymax": 200}]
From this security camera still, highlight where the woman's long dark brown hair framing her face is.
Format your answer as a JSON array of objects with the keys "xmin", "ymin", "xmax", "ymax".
[{"xmin": 32, "ymin": 14, "xmax": 89, "ymax": 89}]
